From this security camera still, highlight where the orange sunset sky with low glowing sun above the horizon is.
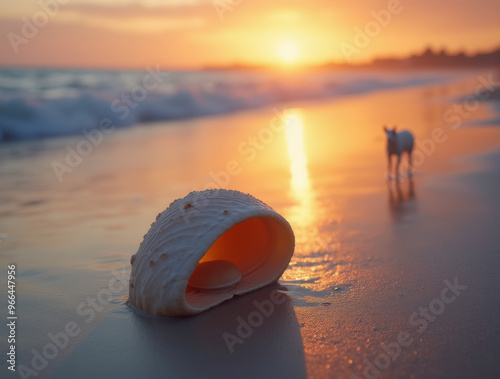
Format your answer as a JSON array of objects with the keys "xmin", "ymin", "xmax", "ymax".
[{"xmin": 0, "ymin": 0, "xmax": 500, "ymax": 68}]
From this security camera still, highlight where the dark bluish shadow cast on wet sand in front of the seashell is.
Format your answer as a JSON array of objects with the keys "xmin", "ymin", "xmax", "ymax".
[{"xmin": 54, "ymin": 285, "xmax": 306, "ymax": 379}]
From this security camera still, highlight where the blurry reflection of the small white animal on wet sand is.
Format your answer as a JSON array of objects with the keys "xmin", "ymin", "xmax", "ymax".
[{"xmin": 387, "ymin": 176, "xmax": 417, "ymax": 222}]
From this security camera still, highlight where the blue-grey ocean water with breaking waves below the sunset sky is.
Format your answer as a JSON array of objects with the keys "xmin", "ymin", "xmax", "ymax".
[{"xmin": 0, "ymin": 67, "xmax": 458, "ymax": 143}]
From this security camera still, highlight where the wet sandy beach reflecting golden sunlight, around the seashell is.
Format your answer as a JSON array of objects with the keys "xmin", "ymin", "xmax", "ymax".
[{"xmin": 0, "ymin": 70, "xmax": 500, "ymax": 379}]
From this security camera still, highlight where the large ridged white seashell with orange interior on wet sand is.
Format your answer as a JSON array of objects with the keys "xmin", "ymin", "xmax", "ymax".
[{"xmin": 128, "ymin": 190, "xmax": 295, "ymax": 316}]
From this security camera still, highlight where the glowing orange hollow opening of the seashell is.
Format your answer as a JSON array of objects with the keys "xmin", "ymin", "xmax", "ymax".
[{"xmin": 186, "ymin": 217, "xmax": 294, "ymax": 308}]
